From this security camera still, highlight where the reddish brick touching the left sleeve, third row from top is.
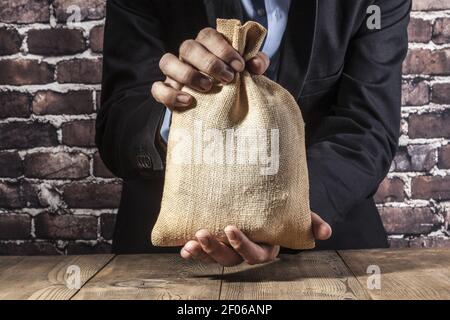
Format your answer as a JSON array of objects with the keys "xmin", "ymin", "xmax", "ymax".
[{"xmin": 57, "ymin": 59, "xmax": 102, "ymax": 84}]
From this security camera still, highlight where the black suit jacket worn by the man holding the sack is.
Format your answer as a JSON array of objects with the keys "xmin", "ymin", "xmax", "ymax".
[{"xmin": 96, "ymin": 0, "xmax": 411, "ymax": 252}]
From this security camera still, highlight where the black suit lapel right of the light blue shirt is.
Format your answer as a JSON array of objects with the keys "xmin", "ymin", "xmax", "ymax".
[{"xmin": 278, "ymin": 0, "xmax": 318, "ymax": 99}]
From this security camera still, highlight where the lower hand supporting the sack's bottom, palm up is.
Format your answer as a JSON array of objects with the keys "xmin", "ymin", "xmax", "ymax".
[{"xmin": 180, "ymin": 212, "xmax": 332, "ymax": 267}]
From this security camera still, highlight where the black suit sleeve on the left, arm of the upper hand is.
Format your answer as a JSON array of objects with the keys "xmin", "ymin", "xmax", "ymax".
[{"xmin": 95, "ymin": 0, "xmax": 165, "ymax": 178}]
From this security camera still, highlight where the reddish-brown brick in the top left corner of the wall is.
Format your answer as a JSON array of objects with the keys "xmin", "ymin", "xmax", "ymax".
[{"xmin": 0, "ymin": 0, "xmax": 50, "ymax": 23}]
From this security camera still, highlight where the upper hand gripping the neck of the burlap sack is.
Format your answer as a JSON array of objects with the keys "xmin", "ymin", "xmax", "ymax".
[{"xmin": 151, "ymin": 28, "xmax": 270, "ymax": 110}]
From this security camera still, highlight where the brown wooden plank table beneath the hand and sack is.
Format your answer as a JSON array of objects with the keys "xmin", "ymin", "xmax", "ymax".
[{"xmin": 0, "ymin": 249, "xmax": 450, "ymax": 300}]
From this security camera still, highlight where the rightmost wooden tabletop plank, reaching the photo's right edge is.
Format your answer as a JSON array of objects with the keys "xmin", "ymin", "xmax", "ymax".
[{"xmin": 339, "ymin": 248, "xmax": 450, "ymax": 300}]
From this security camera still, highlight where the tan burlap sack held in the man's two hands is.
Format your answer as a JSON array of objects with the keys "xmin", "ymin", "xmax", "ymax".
[{"xmin": 151, "ymin": 19, "xmax": 314, "ymax": 249}]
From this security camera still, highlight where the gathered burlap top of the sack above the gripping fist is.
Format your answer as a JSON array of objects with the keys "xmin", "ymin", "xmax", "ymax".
[{"xmin": 217, "ymin": 19, "xmax": 267, "ymax": 61}]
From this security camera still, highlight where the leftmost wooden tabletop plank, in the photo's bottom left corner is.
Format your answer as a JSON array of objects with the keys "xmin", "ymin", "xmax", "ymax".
[{"xmin": 0, "ymin": 255, "xmax": 113, "ymax": 300}]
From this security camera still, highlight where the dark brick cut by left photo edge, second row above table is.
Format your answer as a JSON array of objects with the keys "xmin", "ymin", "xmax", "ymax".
[{"xmin": 0, "ymin": 213, "xmax": 31, "ymax": 240}]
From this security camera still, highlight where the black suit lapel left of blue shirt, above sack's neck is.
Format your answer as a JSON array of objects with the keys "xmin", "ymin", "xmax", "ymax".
[{"xmin": 203, "ymin": 0, "xmax": 243, "ymax": 28}]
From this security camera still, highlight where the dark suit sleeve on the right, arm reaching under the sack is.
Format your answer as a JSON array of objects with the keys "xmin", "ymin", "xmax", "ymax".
[{"xmin": 307, "ymin": 0, "xmax": 411, "ymax": 224}]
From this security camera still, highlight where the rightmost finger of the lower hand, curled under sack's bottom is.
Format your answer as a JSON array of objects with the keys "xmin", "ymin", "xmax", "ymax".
[{"xmin": 225, "ymin": 226, "xmax": 275, "ymax": 264}]
